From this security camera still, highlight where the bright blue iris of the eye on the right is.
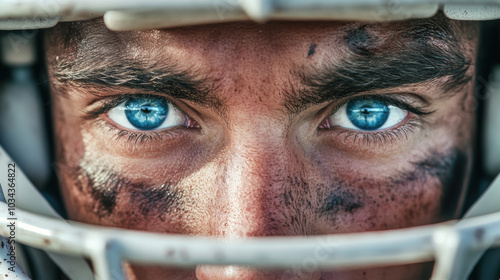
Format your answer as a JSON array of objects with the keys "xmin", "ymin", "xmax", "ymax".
[{"xmin": 346, "ymin": 99, "xmax": 390, "ymax": 130}]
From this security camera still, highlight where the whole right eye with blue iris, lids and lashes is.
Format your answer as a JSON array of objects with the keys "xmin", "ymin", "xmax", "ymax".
[{"xmin": 320, "ymin": 96, "xmax": 431, "ymax": 143}]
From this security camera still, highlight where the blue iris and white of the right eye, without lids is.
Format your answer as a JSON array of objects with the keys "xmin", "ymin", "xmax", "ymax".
[{"xmin": 328, "ymin": 98, "xmax": 408, "ymax": 131}]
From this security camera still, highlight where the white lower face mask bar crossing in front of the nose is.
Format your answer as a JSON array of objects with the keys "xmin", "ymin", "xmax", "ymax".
[{"xmin": 0, "ymin": 144, "xmax": 500, "ymax": 280}]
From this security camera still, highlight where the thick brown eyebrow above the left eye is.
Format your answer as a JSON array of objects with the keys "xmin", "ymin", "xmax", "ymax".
[{"xmin": 54, "ymin": 56, "xmax": 223, "ymax": 110}]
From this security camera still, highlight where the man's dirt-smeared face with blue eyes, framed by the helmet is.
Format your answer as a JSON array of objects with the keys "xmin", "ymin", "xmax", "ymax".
[{"xmin": 46, "ymin": 15, "xmax": 478, "ymax": 279}]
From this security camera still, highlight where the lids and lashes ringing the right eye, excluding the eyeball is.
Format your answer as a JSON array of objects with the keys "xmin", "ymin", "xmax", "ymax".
[{"xmin": 319, "ymin": 95, "xmax": 434, "ymax": 145}]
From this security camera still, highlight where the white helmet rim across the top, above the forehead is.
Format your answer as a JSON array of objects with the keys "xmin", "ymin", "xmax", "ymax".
[{"xmin": 0, "ymin": 0, "xmax": 500, "ymax": 31}]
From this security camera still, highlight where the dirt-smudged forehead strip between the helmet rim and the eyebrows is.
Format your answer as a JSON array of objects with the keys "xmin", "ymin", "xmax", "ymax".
[{"xmin": 49, "ymin": 16, "xmax": 456, "ymax": 68}]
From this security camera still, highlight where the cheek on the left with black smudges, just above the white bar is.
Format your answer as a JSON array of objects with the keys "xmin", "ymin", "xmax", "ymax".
[{"xmin": 60, "ymin": 160, "xmax": 195, "ymax": 233}]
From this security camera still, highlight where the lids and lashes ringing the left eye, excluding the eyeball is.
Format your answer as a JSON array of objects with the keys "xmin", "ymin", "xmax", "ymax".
[{"xmin": 83, "ymin": 94, "xmax": 195, "ymax": 144}]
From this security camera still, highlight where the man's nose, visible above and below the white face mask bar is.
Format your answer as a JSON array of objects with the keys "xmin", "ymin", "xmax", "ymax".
[{"xmin": 196, "ymin": 134, "xmax": 321, "ymax": 280}]
